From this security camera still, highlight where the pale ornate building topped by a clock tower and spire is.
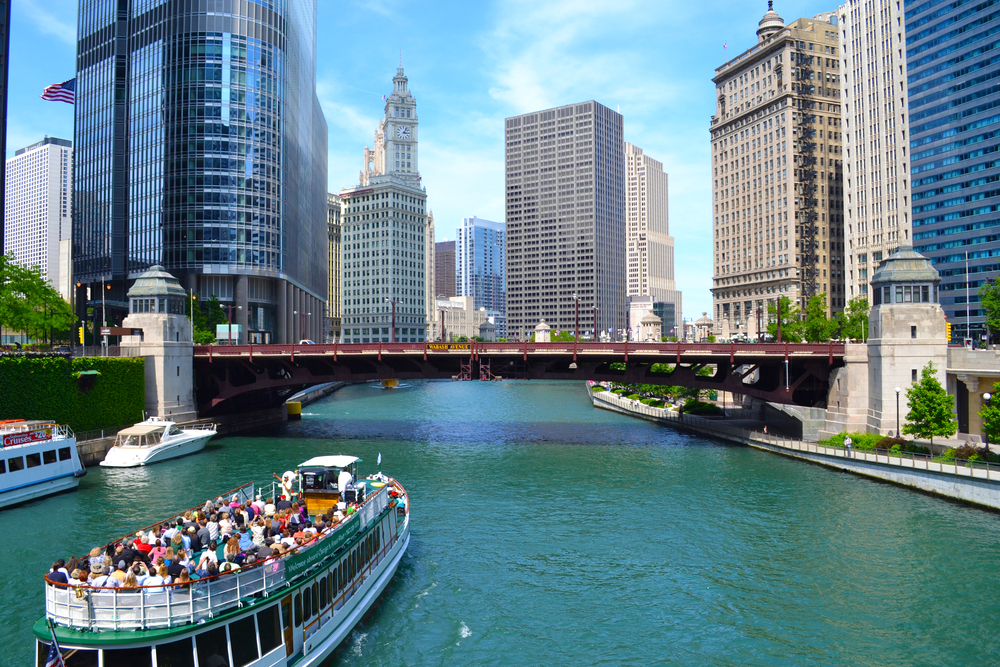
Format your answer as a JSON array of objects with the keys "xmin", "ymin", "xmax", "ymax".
[{"xmin": 341, "ymin": 67, "xmax": 427, "ymax": 343}]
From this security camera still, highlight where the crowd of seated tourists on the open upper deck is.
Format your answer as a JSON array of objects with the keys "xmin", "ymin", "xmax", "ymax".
[{"xmin": 47, "ymin": 495, "xmax": 357, "ymax": 591}]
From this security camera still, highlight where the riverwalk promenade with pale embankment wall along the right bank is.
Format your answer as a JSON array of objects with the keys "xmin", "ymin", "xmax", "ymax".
[{"xmin": 587, "ymin": 383, "xmax": 1000, "ymax": 510}]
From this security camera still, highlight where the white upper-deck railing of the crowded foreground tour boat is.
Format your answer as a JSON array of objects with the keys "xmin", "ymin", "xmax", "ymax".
[{"xmin": 45, "ymin": 483, "xmax": 401, "ymax": 632}]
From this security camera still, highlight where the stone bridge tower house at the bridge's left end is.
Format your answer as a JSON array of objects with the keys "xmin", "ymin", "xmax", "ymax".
[{"xmin": 122, "ymin": 266, "xmax": 198, "ymax": 422}]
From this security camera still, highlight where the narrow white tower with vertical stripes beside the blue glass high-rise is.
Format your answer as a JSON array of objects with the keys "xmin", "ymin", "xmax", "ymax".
[{"xmin": 839, "ymin": 0, "xmax": 911, "ymax": 300}]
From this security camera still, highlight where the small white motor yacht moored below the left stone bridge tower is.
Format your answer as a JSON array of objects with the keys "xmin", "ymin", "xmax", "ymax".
[{"xmin": 101, "ymin": 417, "xmax": 218, "ymax": 468}]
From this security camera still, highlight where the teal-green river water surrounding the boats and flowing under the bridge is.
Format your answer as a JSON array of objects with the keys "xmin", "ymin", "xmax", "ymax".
[{"xmin": 0, "ymin": 382, "xmax": 1000, "ymax": 666}]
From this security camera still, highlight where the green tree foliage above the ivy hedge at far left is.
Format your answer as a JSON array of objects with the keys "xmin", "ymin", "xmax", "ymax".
[{"xmin": 0, "ymin": 255, "xmax": 76, "ymax": 340}]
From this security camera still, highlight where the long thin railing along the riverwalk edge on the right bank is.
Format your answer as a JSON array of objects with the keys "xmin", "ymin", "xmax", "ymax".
[{"xmin": 588, "ymin": 387, "xmax": 1000, "ymax": 481}]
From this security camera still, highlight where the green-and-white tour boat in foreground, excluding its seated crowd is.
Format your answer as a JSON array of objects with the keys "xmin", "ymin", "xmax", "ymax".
[{"xmin": 33, "ymin": 456, "xmax": 410, "ymax": 667}]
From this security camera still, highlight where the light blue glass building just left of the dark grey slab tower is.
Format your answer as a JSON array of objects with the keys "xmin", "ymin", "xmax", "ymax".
[{"xmin": 455, "ymin": 216, "xmax": 507, "ymax": 336}]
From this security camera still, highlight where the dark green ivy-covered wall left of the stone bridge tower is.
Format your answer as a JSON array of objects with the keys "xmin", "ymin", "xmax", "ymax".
[{"xmin": 0, "ymin": 356, "xmax": 146, "ymax": 431}]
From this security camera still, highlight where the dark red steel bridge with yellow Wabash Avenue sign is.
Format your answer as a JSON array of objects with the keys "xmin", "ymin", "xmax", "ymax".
[{"xmin": 194, "ymin": 341, "xmax": 844, "ymax": 417}]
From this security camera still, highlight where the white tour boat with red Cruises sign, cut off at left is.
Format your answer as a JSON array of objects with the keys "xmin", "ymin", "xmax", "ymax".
[{"xmin": 0, "ymin": 419, "xmax": 87, "ymax": 508}]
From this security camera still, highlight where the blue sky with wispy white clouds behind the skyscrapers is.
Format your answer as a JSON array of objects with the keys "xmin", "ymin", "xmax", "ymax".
[{"xmin": 7, "ymin": 0, "xmax": 837, "ymax": 319}]
